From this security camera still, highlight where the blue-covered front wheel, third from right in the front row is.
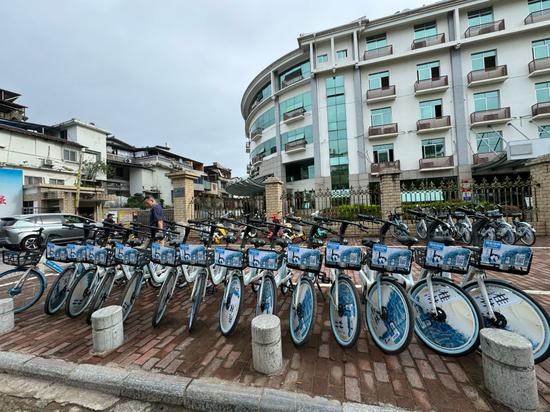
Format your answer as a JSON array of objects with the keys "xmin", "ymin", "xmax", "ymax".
[{"xmin": 365, "ymin": 278, "xmax": 414, "ymax": 354}]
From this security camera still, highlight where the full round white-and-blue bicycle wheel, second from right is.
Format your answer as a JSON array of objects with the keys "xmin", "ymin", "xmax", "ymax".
[{"xmin": 410, "ymin": 278, "xmax": 482, "ymax": 356}]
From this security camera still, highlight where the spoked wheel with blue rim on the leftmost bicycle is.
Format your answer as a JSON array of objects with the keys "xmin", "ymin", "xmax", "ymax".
[{"xmin": 0, "ymin": 268, "xmax": 46, "ymax": 313}]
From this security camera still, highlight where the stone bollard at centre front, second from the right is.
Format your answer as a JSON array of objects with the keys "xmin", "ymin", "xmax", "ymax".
[{"xmin": 252, "ymin": 315, "xmax": 283, "ymax": 375}]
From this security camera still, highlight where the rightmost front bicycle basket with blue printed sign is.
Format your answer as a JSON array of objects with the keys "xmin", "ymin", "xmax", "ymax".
[{"xmin": 476, "ymin": 240, "xmax": 533, "ymax": 275}]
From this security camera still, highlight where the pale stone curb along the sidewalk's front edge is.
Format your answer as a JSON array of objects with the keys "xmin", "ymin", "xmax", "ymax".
[{"xmin": 0, "ymin": 351, "xmax": 405, "ymax": 412}]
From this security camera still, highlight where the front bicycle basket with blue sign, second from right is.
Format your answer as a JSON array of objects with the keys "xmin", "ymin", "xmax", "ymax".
[{"xmin": 422, "ymin": 242, "xmax": 472, "ymax": 274}]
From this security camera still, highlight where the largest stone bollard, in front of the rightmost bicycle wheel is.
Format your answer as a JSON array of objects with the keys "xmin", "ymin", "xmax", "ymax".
[{"xmin": 481, "ymin": 328, "xmax": 539, "ymax": 410}]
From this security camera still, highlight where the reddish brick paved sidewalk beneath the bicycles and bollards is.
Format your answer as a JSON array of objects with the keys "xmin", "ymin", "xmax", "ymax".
[{"xmin": 0, "ymin": 246, "xmax": 550, "ymax": 411}]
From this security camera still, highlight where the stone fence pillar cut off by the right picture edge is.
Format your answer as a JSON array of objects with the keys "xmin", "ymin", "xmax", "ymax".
[{"xmin": 527, "ymin": 154, "xmax": 550, "ymax": 236}]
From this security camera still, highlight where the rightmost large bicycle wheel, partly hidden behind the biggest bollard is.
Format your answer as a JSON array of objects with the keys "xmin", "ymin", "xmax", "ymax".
[{"xmin": 464, "ymin": 279, "xmax": 550, "ymax": 363}]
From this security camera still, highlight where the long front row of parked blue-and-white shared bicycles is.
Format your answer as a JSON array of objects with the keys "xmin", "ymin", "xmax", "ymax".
[{"xmin": 0, "ymin": 208, "xmax": 550, "ymax": 362}]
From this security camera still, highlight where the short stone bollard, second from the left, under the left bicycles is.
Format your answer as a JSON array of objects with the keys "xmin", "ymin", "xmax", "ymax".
[{"xmin": 92, "ymin": 306, "xmax": 124, "ymax": 354}]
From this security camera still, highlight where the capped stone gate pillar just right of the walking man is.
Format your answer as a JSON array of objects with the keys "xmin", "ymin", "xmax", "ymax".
[{"xmin": 167, "ymin": 170, "xmax": 205, "ymax": 224}]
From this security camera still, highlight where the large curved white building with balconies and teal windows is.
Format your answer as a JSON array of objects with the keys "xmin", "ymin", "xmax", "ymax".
[{"xmin": 241, "ymin": 0, "xmax": 550, "ymax": 189}]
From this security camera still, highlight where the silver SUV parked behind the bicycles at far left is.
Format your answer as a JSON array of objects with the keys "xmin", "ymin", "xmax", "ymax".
[{"xmin": 0, "ymin": 213, "xmax": 94, "ymax": 250}]
